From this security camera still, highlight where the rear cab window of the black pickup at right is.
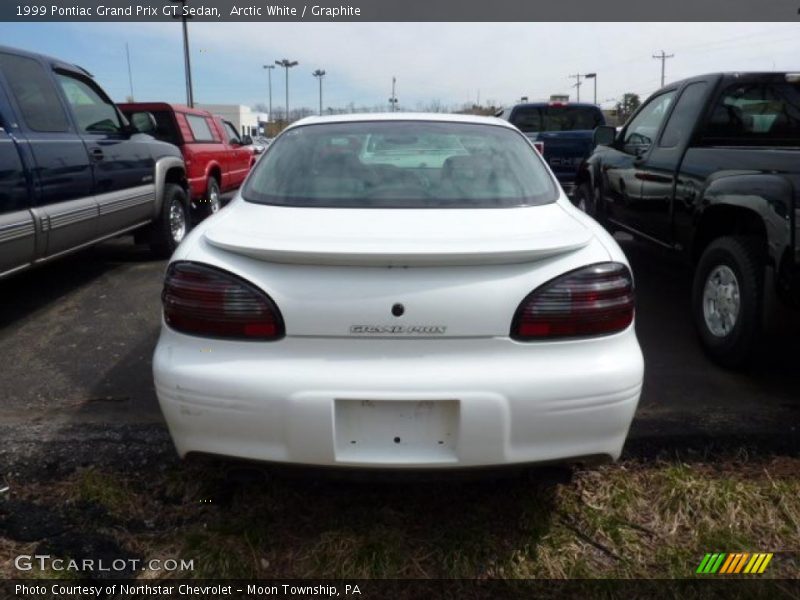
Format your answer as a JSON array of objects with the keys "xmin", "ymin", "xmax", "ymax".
[{"xmin": 703, "ymin": 83, "xmax": 800, "ymax": 146}]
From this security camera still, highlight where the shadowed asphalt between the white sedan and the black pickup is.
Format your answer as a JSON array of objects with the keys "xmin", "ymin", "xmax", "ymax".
[{"xmin": 619, "ymin": 234, "xmax": 800, "ymax": 453}]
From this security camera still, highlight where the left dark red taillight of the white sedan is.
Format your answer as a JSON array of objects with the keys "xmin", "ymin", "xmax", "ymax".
[{"xmin": 161, "ymin": 262, "xmax": 285, "ymax": 341}]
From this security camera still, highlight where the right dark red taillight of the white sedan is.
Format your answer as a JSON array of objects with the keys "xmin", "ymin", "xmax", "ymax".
[{"xmin": 511, "ymin": 262, "xmax": 634, "ymax": 340}]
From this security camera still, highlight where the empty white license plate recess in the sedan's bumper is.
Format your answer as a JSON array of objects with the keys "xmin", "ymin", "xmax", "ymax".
[{"xmin": 334, "ymin": 399, "xmax": 459, "ymax": 464}]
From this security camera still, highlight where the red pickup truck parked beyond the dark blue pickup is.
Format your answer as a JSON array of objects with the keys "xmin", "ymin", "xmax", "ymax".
[{"xmin": 119, "ymin": 102, "xmax": 256, "ymax": 215}]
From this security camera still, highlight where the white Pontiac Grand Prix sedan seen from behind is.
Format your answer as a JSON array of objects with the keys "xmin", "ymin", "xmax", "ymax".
[{"xmin": 153, "ymin": 114, "xmax": 643, "ymax": 469}]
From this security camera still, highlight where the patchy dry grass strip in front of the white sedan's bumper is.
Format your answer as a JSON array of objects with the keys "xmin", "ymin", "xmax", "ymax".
[{"xmin": 0, "ymin": 456, "xmax": 800, "ymax": 579}]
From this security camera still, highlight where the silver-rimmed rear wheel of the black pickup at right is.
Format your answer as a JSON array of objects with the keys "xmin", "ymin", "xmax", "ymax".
[{"xmin": 692, "ymin": 236, "xmax": 764, "ymax": 368}]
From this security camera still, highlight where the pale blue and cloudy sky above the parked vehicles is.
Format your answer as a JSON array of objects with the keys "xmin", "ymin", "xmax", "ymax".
[{"xmin": 0, "ymin": 22, "xmax": 800, "ymax": 110}]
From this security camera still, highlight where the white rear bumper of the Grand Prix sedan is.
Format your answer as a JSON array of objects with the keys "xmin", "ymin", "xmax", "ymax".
[{"xmin": 153, "ymin": 327, "xmax": 643, "ymax": 469}]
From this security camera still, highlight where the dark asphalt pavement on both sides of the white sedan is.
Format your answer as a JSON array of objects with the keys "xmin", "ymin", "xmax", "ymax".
[{"xmin": 0, "ymin": 238, "xmax": 800, "ymax": 471}]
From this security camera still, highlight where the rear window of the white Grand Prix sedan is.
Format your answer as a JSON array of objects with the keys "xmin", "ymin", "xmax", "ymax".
[{"xmin": 242, "ymin": 121, "xmax": 556, "ymax": 208}]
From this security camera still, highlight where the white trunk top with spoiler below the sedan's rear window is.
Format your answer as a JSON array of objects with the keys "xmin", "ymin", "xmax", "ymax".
[{"xmin": 204, "ymin": 201, "xmax": 592, "ymax": 267}]
